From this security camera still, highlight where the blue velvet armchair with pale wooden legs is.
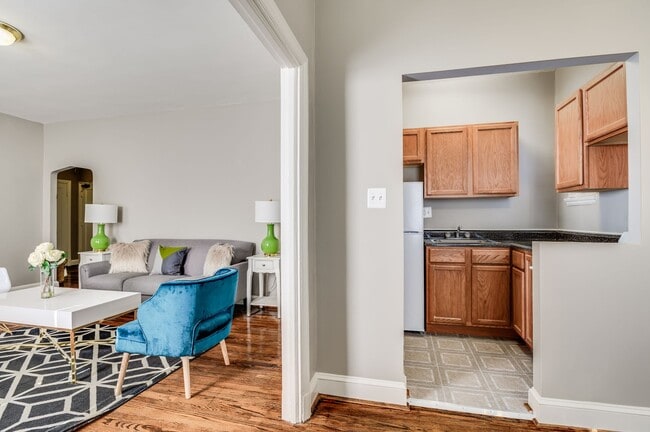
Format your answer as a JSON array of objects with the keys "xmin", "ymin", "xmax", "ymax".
[{"xmin": 115, "ymin": 268, "xmax": 239, "ymax": 399}]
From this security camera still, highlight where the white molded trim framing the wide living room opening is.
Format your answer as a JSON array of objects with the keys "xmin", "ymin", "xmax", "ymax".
[{"xmin": 229, "ymin": 0, "xmax": 313, "ymax": 423}]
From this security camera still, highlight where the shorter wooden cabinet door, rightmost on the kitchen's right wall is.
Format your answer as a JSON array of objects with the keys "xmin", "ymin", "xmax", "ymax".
[{"xmin": 582, "ymin": 63, "xmax": 627, "ymax": 144}]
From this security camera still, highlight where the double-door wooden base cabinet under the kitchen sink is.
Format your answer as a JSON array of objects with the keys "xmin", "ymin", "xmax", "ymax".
[{"xmin": 426, "ymin": 247, "xmax": 515, "ymax": 336}]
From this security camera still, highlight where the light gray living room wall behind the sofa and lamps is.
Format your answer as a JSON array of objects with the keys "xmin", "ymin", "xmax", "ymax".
[{"xmin": 43, "ymin": 101, "xmax": 280, "ymax": 250}]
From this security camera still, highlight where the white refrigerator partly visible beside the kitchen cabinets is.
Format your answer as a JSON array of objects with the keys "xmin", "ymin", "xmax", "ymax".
[{"xmin": 404, "ymin": 182, "xmax": 424, "ymax": 331}]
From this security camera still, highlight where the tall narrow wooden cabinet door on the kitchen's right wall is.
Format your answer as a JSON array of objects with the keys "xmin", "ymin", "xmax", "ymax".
[{"xmin": 555, "ymin": 90, "xmax": 584, "ymax": 189}]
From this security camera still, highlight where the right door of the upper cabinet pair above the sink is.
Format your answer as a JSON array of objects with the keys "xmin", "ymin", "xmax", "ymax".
[{"xmin": 471, "ymin": 122, "xmax": 519, "ymax": 196}]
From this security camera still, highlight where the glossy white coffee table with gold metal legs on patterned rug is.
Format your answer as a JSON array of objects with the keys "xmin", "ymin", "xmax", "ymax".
[{"xmin": 0, "ymin": 287, "xmax": 140, "ymax": 382}]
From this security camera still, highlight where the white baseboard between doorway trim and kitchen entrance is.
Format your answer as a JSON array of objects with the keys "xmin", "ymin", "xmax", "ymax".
[{"xmin": 311, "ymin": 372, "xmax": 406, "ymax": 406}]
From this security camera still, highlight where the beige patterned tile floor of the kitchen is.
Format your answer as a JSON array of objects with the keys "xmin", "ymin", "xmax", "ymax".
[{"xmin": 404, "ymin": 332, "xmax": 533, "ymax": 414}]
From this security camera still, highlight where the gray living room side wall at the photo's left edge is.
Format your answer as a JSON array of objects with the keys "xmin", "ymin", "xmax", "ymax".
[{"xmin": 0, "ymin": 114, "xmax": 43, "ymax": 286}]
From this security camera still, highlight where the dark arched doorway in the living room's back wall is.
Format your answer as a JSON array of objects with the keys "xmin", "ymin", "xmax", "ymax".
[{"xmin": 56, "ymin": 167, "xmax": 93, "ymax": 264}]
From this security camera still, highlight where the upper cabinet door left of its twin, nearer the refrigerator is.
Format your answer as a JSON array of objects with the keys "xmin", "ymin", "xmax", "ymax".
[{"xmin": 424, "ymin": 126, "xmax": 469, "ymax": 197}]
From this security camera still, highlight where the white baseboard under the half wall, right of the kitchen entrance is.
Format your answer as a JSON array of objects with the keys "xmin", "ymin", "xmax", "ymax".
[{"xmin": 528, "ymin": 387, "xmax": 650, "ymax": 432}]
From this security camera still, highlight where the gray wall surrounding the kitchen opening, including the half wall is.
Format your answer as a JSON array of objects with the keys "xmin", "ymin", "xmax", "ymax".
[{"xmin": 316, "ymin": 0, "xmax": 650, "ymax": 426}]
